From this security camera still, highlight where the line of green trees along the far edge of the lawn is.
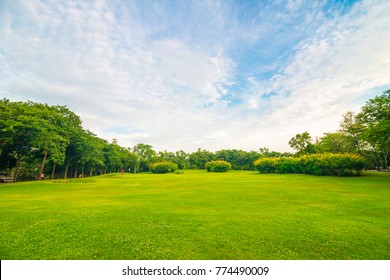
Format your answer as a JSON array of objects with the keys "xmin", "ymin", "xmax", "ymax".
[{"xmin": 0, "ymin": 90, "xmax": 390, "ymax": 181}]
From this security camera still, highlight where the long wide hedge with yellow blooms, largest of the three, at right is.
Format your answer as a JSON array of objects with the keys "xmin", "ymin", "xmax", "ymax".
[{"xmin": 254, "ymin": 153, "xmax": 365, "ymax": 176}]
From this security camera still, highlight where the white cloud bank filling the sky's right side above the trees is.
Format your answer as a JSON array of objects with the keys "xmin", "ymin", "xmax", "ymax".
[{"xmin": 241, "ymin": 1, "xmax": 390, "ymax": 149}]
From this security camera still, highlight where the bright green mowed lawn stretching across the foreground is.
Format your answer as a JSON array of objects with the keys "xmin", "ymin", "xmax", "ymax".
[{"xmin": 0, "ymin": 171, "xmax": 390, "ymax": 260}]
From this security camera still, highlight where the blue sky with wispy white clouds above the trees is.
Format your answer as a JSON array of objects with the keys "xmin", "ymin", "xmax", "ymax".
[{"xmin": 0, "ymin": 0, "xmax": 390, "ymax": 152}]
